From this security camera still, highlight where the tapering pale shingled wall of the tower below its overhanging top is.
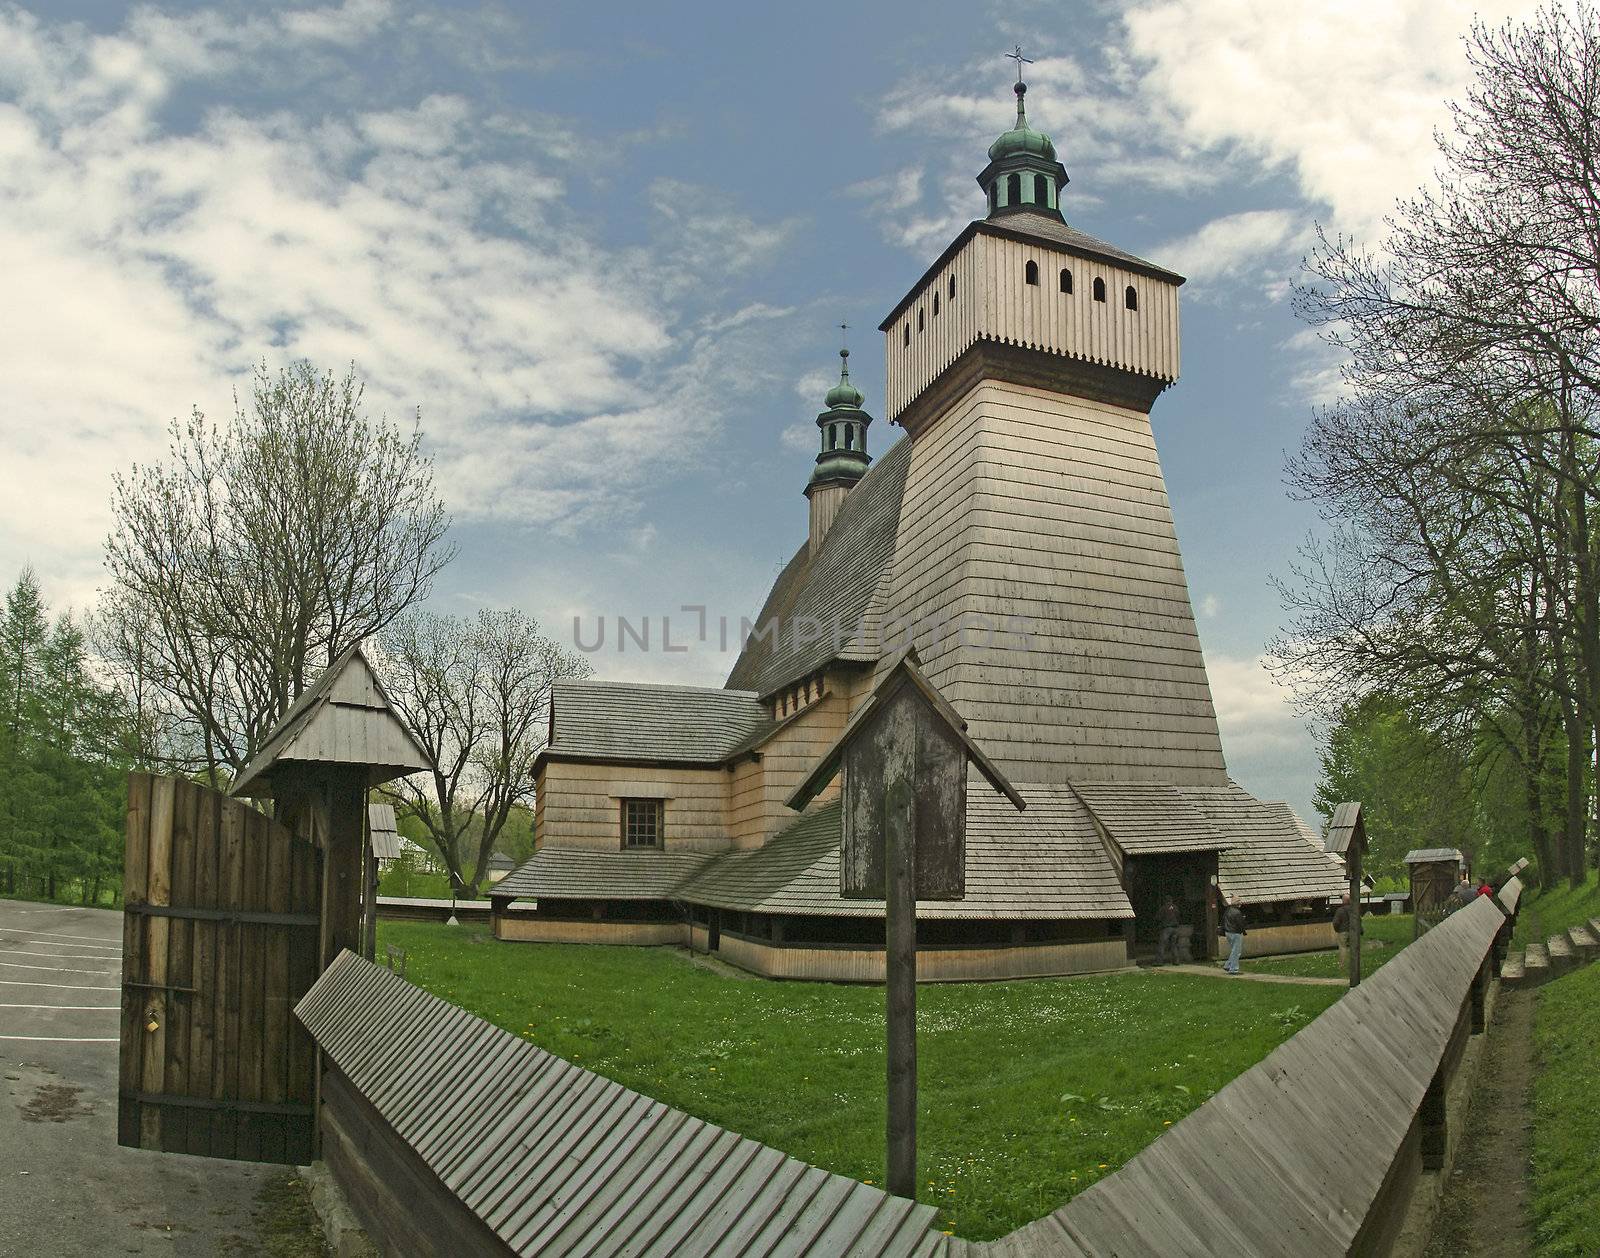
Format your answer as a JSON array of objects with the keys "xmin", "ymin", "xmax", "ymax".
[{"xmin": 883, "ymin": 383, "xmax": 1227, "ymax": 784}]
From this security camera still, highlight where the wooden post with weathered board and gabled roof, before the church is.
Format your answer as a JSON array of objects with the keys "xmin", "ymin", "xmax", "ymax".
[{"xmin": 787, "ymin": 650, "xmax": 1026, "ymax": 1199}]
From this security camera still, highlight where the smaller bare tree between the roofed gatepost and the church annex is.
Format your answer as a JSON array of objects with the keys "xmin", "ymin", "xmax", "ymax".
[{"xmin": 381, "ymin": 610, "xmax": 590, "ymax": 895}]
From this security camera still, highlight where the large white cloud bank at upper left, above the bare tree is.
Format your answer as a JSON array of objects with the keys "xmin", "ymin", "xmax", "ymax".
[{"xmin": 0, "ymin": 0, "xmax": 794, "ymax": 605}]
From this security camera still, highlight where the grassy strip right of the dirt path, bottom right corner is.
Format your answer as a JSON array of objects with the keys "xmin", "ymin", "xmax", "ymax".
[{"xmin": 1533, "ymin": 965, "xmax": 1600, "ymax": 1258}]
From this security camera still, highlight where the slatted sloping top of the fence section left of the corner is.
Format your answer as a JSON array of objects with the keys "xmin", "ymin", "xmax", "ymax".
[{"xmin": 296, "ymin": 952, "xmax": 944, "ymax": 1258}]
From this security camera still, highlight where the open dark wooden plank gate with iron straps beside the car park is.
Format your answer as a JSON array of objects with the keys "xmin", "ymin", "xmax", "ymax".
[{"xmin": 117, "ymin": 773, "xmax": 322, "ymax": 1164}]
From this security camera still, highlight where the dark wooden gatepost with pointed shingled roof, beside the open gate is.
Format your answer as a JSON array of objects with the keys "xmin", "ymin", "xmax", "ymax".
[{"xmin": 230, "ymin": 643, "xmax": 432, "ymax": 972}]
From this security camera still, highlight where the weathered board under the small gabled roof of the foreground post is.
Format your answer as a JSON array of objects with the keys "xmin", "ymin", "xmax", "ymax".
[{"xmin": 838, "ymin": 685, "xmax": 966, "ymax": 899}]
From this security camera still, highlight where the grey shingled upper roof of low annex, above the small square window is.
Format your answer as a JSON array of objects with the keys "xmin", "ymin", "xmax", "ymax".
[{"xmin": 542, "ymin": 682, "xmax": 774, "ymax": 765}]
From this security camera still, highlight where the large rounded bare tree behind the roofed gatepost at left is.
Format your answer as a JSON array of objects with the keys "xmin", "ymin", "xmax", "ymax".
[{"xmin": 99, "ymin": 362, "xmax": 453, "ymax": 784}]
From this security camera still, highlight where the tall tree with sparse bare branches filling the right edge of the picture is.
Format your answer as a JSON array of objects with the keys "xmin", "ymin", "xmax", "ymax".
[{"xmin": 1277, "ymin": 2, "xmax": 1600, "ymax": 879}]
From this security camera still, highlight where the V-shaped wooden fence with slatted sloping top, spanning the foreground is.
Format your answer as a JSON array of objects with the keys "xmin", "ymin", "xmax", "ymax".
[{"xmin": 298, "ymin": 880, "xmax": 1520, "ymax": 1258}]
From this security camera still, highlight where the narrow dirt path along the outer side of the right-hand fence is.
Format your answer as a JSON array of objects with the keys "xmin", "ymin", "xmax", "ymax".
[{"xmin": 1427, "ymin": 988, "xmax": 1533, "ymax": 1258}]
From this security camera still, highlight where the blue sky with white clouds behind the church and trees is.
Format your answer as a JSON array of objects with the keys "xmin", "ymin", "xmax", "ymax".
[{"xmin": 0, "ymin": 0, "xmax": 1533, "ymax": 818}]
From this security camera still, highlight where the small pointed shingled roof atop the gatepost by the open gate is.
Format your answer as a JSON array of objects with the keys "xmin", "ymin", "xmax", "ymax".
[{"xmin": 229, "ymin": 643, "xmax": 434, "ymax": 797}]
